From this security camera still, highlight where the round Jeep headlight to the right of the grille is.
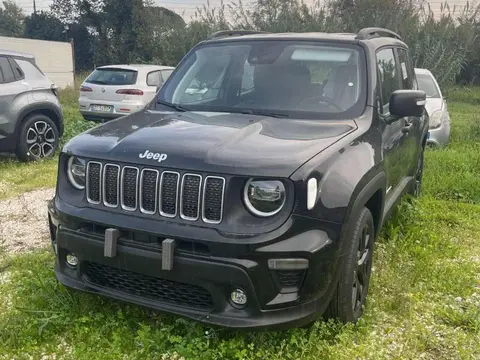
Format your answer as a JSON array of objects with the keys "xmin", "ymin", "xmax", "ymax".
[{"xmin": 243, "ymin": 179, "xmax": 286, "ymax": 217}]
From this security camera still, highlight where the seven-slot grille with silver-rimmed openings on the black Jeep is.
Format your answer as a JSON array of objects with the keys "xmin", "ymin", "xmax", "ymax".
[{"xmin": 86, "ymin": 161, "xmax": 225, "ymax": 224}]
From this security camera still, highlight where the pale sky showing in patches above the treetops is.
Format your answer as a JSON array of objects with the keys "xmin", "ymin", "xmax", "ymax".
[{"xmin": 10, "ymin": 0, "xmax": 480, "ymax": 21}]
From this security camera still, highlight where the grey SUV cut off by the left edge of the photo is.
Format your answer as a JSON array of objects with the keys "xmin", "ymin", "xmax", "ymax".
[{"xmin": 0, "ymin": 50, "xmax": 63, "ymax": 161}]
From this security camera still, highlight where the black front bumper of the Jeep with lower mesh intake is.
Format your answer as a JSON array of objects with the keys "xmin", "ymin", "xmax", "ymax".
[{"xmin": 49, "ymin": 200, "xmax": 338, "ymax": 329}]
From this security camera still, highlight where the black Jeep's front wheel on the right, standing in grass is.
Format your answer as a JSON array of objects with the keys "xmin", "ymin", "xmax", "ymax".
[{"xmin": 324, "ymin": 207, "xmax": 375, "ymax": 323}]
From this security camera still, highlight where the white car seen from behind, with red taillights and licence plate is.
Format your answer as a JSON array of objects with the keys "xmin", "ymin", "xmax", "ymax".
[{"xmin": 78, "ymin": 65, "xmax": 174, "ymax": 121}]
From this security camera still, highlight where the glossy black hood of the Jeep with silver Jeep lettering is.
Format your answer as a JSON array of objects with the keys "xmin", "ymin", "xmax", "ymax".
[{"xmin": 64, "ymin": 110, "xmax": 357, "ymax": 177}]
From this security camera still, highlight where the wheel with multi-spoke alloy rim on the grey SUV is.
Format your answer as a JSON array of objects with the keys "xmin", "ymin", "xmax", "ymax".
[{"xmin": 15, "ymin": 114, "xmax": 59, "ymax": 162}]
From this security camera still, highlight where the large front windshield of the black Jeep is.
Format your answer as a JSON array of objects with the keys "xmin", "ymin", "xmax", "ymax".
[{"xmin": 157, "ymin": 40, "xmax": 366, "ymax": 118}]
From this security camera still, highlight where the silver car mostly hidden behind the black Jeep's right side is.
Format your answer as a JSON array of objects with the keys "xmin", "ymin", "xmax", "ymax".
[{"xmin": 415, "ymin": 68, "xmax": 450, "ymax": 147}]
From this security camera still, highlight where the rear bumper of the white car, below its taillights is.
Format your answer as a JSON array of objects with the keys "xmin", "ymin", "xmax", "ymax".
[{"xmin": 78, "ymin": 97, "xmax": 146, "ymax": 121}]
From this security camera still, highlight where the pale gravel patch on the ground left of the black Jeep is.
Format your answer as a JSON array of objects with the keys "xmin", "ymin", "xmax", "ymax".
[{"xmin": 0, "ymin": 189, "xmax": 55, "ymax": 253}]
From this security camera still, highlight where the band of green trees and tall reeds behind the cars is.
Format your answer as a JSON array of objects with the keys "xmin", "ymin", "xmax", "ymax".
[{"xmin": 0, "ymin": 0, "xmax": 480, "ymax": 84}]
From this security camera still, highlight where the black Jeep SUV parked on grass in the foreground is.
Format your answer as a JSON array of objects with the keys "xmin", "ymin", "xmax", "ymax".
[{"xmin": 49, "ymin": 28, "xmax": 428, "ymax": 328}]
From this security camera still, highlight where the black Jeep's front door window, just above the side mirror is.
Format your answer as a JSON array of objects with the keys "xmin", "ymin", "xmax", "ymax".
[{"xmin": 377, "ymin": 49, "xmax": 400, "ymax": 114}]
